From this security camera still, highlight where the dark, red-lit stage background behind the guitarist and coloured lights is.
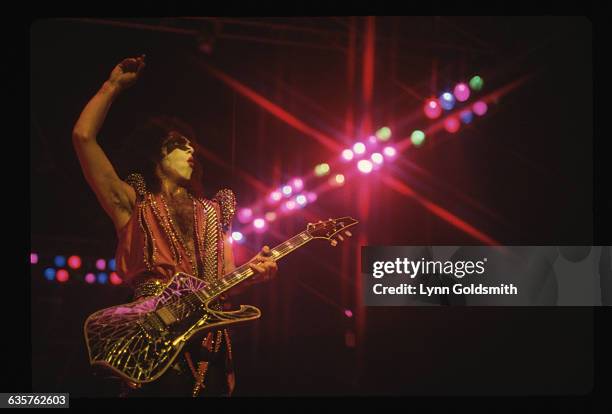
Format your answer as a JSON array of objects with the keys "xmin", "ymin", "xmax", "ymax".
[{"xmin": 30, "ymin": 17, "xmax": 596, "ymax": 397}]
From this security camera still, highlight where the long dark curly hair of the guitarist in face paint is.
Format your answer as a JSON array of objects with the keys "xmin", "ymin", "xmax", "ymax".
[{"xmin": 121, "ymin": 115, "xmax": 204, "ymax": 197}]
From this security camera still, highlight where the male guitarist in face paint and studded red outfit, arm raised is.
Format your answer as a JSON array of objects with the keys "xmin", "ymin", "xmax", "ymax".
[{"xmin": 72, "ymin": 55, "xmax": 277, "ymax": 396}]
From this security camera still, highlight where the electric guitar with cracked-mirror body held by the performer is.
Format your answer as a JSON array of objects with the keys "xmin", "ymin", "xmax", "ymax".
[{"xmin": 84, "ymin": 217, "xmax": 358, "ymax": 384}]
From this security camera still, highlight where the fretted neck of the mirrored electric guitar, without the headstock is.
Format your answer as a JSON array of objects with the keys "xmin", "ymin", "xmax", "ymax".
[{"xmin": 202, "ymin": 231, "xmax": 313, "ymax": 297}]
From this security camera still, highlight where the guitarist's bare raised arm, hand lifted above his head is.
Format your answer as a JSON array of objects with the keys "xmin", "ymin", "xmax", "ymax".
[{"xmin": 72, "ymin": 55, "xmax": 145, "ymax": 229}]
